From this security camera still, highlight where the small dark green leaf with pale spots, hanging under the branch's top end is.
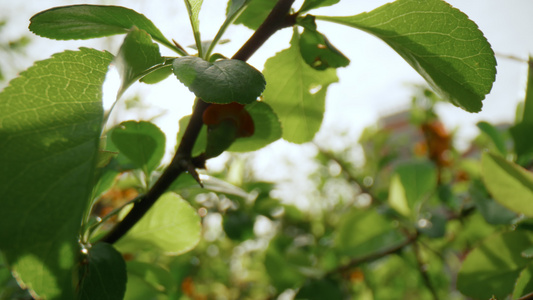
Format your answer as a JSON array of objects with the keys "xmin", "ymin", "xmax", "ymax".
[{"xmin": 299, "ymin": 28, "xmax": 350, "ymax": 70}]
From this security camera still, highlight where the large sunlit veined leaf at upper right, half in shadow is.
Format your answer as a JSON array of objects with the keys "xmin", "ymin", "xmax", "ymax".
[{"xmin": 316, "ymin": 0, "xmax": 496, "ymax": 112}]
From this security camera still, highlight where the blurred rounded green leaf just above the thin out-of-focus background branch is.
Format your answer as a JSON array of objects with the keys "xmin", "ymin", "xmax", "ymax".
[{"xmin": 335, "ymin": 210, "xmax": 405, "ymax": 257}]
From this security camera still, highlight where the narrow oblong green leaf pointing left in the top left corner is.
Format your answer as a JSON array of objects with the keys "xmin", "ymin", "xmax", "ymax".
[{"xmin": 30, "ymin": 4, "xmax": 176, "ymax": 49}]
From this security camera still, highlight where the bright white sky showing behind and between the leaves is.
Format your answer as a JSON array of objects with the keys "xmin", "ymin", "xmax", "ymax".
[{"xmin": 0, "ymin": 0, "xmax": 533, "ymax": 197}]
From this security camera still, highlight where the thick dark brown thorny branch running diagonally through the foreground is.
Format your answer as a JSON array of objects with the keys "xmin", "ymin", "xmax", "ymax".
[{"xmin": 101, "ymin": 0, "xmax": 296, "ymax": 244}]
